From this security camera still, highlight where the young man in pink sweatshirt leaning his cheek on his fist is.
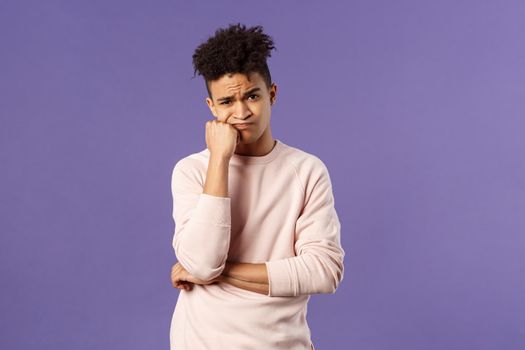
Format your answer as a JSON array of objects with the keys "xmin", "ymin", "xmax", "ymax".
[{"xmin": 170, "ymin": 24, "xmax": 345, "ymax": 350}]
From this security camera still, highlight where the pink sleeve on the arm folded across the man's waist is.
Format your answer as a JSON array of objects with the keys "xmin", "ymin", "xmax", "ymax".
[{"xmin": 266, "ymin": 158, "xmax": 345, "ymax": 296}]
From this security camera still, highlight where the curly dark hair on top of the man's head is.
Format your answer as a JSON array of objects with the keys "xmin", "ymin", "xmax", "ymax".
[{"xmin": 193, "ymin": 23, "xmax": 277, "ymax": 98}]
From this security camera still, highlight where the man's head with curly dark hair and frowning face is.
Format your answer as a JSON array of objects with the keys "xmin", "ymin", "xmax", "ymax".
[{"xmin": 193, "ymin": 24, "xmax": 277, "ymax": 143}]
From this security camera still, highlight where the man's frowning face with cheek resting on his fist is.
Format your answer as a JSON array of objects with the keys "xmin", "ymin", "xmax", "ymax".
[{"xmin": 206, "ymin": 72, "xmax": 277, "ymax": 143}]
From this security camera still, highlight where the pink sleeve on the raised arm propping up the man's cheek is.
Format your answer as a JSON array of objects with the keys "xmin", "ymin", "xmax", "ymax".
[{"xmin": 171, "ymin": 158, "xmax": 231, "ymax": 281}]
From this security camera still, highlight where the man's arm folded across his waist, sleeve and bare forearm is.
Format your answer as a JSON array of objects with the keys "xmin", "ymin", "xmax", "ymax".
[{"xmin": 216, "ymin": 160, "xmax": 344, "ymax": 296}]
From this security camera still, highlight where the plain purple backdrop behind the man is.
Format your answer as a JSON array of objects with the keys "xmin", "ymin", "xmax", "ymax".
[{"xmin": 0, "ymin": 0, "xmax": 525, "ymax": 350}]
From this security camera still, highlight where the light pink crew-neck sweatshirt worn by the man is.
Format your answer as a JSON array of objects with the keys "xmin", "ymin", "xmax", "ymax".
[{"xmin": 170, "ymin": 140, "xmax": 345, "ymax": 350}]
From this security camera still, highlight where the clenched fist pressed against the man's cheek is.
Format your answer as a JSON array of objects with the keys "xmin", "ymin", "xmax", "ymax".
[{"xmin": 206, "ymin": 120, "xmax": 240, "ymax": 159}]
